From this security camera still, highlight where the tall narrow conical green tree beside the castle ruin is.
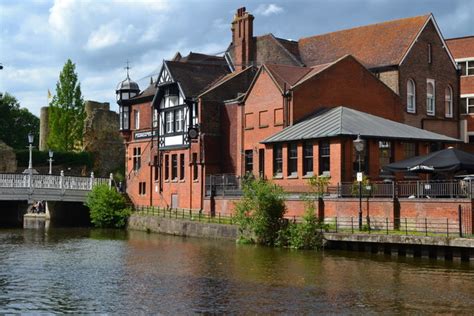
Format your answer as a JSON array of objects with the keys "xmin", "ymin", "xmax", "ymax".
[{"xmin": 47, "ymin": 59, "xmax": 85, "ymax": 151}]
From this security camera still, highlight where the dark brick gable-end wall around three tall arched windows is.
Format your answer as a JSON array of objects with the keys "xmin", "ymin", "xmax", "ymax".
[{"xmin": 399, "ymin": 21, "xmax": 459, "ymax": 138}]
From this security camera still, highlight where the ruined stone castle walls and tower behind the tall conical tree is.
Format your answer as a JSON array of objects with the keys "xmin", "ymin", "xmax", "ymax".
[{"xmin": 39, "ymin": 100, "xmax": 125, "ymax": 176}]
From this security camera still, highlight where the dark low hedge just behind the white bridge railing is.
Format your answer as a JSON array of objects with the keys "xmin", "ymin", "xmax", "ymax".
[{"xmin": 15, "ymin": 149, "xmax": 93, "ymax": 168}]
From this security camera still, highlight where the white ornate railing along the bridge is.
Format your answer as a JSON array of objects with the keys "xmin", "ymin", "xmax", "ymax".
[{"xmin": 0, "ymin": 172, "xmax": 112, "ymax": 191}]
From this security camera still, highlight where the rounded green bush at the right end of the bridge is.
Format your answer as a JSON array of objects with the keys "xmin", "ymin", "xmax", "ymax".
[{"xmin": 84, "ymin": 184, "xmax": 131, "ymax": 228}]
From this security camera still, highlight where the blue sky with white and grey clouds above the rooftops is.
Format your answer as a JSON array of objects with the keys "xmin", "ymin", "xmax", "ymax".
[{"xmin": 0, "ymin": 0, "xmax": 474, "ymax": 116}]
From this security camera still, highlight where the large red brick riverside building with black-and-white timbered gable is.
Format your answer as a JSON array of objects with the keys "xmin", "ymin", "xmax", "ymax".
[{"xmin": 117, "ymin": 8, "xmax": 459, "ymax": 216}]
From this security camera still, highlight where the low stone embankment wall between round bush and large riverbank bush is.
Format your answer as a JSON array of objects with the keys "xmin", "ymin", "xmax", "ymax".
[{"xmin": 127, "ymin": 214, "xmax": 238, "ymax": 240}]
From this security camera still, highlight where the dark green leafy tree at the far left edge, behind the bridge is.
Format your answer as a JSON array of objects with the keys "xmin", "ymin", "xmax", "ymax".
[{"xmin": 0, "ymin": 93, "xmax": 39, "ymax": 149}]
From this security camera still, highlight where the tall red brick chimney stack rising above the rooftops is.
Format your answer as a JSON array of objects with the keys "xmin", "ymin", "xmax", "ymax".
[{"xmin": 231, "ymin": 7, "xmax": 255, "ymax": 70}]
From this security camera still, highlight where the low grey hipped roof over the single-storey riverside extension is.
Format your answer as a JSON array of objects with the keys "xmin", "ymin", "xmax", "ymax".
[{"xmin": 262, "ymin": 106, "xmax": 460, "ymax": 143}]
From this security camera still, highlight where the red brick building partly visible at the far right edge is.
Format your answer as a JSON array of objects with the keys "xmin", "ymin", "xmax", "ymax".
[{"xmin": 446, "ymin": 36, "xmax": 474, "ymax": 144}]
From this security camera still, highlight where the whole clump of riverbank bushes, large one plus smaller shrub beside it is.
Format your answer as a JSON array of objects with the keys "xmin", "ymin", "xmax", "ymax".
[{"xmin": 235, "ymin": 178, "xmax": 326, "ymax": 249}]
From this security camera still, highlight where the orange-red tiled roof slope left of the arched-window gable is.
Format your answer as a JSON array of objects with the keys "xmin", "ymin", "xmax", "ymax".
[{"xmin": 298, "ymin": 15, "xmax": 430, "ymax": 68}]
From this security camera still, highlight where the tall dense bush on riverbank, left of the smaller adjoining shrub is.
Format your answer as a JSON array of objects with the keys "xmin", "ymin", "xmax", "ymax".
[{"xmin": 235, "ymin": 178, "xmax": 285, "ymax": 246}]
